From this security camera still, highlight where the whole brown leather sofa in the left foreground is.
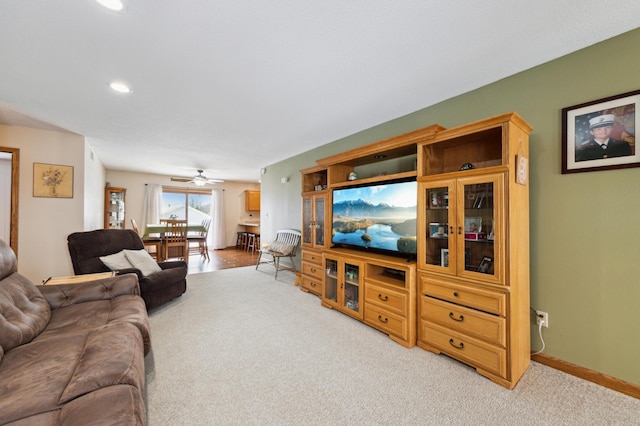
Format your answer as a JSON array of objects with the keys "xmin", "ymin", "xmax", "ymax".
[{"xmin": 0, "ymin": 240, "xmax": 151, "ymax": 426}]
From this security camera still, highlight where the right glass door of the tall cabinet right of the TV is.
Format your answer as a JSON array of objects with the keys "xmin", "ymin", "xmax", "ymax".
[{"xmin": 458, "ymin": 175, "xmax": 502, "ymax": 278}]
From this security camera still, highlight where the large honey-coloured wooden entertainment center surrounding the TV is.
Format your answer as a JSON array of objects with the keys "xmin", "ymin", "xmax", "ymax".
[{"xmin": 301, "ymin": 113, "xmax": 532, "ymax": 389}]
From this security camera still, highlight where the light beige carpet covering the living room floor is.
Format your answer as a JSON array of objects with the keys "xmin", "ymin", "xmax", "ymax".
[{"xmin": 146, "ymin": 265, "xmax": 640, "ymax": 426}]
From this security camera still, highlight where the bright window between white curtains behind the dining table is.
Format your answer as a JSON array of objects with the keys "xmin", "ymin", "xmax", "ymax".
[{"xmin": 160, "ymin": 188, "xmax": 211, "ymax": 225}]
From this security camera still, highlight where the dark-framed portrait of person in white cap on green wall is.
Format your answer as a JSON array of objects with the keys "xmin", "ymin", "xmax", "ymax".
[{"xmin": 562, "ymin": 90, "xmax": 640, "ymax": 174}]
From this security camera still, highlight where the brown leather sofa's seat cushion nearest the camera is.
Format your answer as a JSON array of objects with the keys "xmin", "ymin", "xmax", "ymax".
[{"xmin": 0, "ymin": 324, "xmax": 144, "ymax": 424}]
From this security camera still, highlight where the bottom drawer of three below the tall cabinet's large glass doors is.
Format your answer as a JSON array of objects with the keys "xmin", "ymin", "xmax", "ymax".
[{"xmin": 420, "ymin": 320, "xmax": 507, "ymax": 378}]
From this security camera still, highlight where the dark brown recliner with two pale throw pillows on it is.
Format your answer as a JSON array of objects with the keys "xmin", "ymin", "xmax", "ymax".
[{"xmin": 67, "ymin": 229, "xmax": 187, "ymax": 310}]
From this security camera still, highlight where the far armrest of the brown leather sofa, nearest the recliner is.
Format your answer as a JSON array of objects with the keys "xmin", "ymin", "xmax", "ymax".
[{"xmin": 38, "ymin": 274, "xmax": 140, "ymax": 309}]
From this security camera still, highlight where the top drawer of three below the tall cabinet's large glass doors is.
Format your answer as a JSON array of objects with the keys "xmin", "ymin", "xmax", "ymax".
[{"xmin": 420, "ymin": 275, "xmax": 507, "ymax": 316}]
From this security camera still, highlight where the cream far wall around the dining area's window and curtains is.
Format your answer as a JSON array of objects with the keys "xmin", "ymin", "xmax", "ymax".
[{"xmin": 106, "ymin": 170, "xmax": 260, "ymax": 247}]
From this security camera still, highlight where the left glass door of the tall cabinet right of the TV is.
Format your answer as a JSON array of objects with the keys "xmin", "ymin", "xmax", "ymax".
[{"xmin": 420, "ymin": 181, "xmax": 456, "ymax": 273}]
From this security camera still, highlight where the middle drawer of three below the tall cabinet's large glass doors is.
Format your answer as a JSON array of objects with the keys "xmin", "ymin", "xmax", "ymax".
[{"xmin": 420, "ymin": 296, "xmax": 507, "ymax": 348}]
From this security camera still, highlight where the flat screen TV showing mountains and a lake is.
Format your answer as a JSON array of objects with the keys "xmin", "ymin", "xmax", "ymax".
[{"xmin": 331, "ymin": 181, "xmax": 418, "ymax": 258}]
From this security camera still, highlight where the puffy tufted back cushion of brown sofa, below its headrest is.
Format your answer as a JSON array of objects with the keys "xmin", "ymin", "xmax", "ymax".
[{"xmin": 0, "ymin": 272, "xmax": 51, "ymax": 356}]
